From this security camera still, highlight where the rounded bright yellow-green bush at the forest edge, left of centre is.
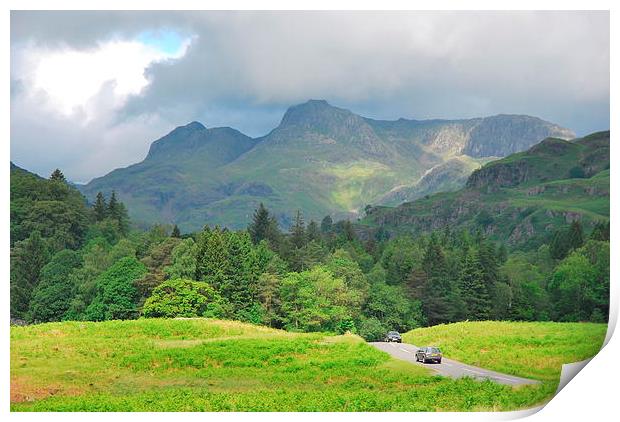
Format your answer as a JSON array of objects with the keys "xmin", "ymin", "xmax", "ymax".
[{"xmin": 142, "ymin": 279, "xmax": 225, "ymax": 318}]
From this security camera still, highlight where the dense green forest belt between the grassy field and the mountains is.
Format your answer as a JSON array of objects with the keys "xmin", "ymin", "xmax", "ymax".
[{"xmin": 10, "ymin": 168, "xmax": 609, "ymax": 340}]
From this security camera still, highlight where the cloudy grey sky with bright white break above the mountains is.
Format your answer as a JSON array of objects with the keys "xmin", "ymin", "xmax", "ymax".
[{"xmin": 10, "ymin": 11, "xmax": 609, "ymax": 183}]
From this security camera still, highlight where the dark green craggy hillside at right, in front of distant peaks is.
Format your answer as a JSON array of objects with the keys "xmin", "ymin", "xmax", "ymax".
[{"xmin": 358, "ymin": 131, "xmax": 610, "ymax": 248}]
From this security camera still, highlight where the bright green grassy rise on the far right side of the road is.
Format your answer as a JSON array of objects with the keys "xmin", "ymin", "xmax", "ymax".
[{"xmin": 403, "ymin": 321, "xmax": 607, "ymax": 382}]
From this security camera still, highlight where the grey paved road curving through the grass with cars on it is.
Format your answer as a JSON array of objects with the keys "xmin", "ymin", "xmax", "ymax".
[{"xmin": 370, "ymin": 343, "xmax": 540, "ymax": 386}]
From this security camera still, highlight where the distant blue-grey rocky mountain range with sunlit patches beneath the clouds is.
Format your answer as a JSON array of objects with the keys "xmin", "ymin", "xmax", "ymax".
[{"xmin": 80, "ymin": 100, "xmax": 574, "ymax": 230}]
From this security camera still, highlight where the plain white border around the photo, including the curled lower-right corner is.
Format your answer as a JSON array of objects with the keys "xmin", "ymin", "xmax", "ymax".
[{"xmin": 0, "ymin": 0, "xmax": 620, "ymax": 422}]
